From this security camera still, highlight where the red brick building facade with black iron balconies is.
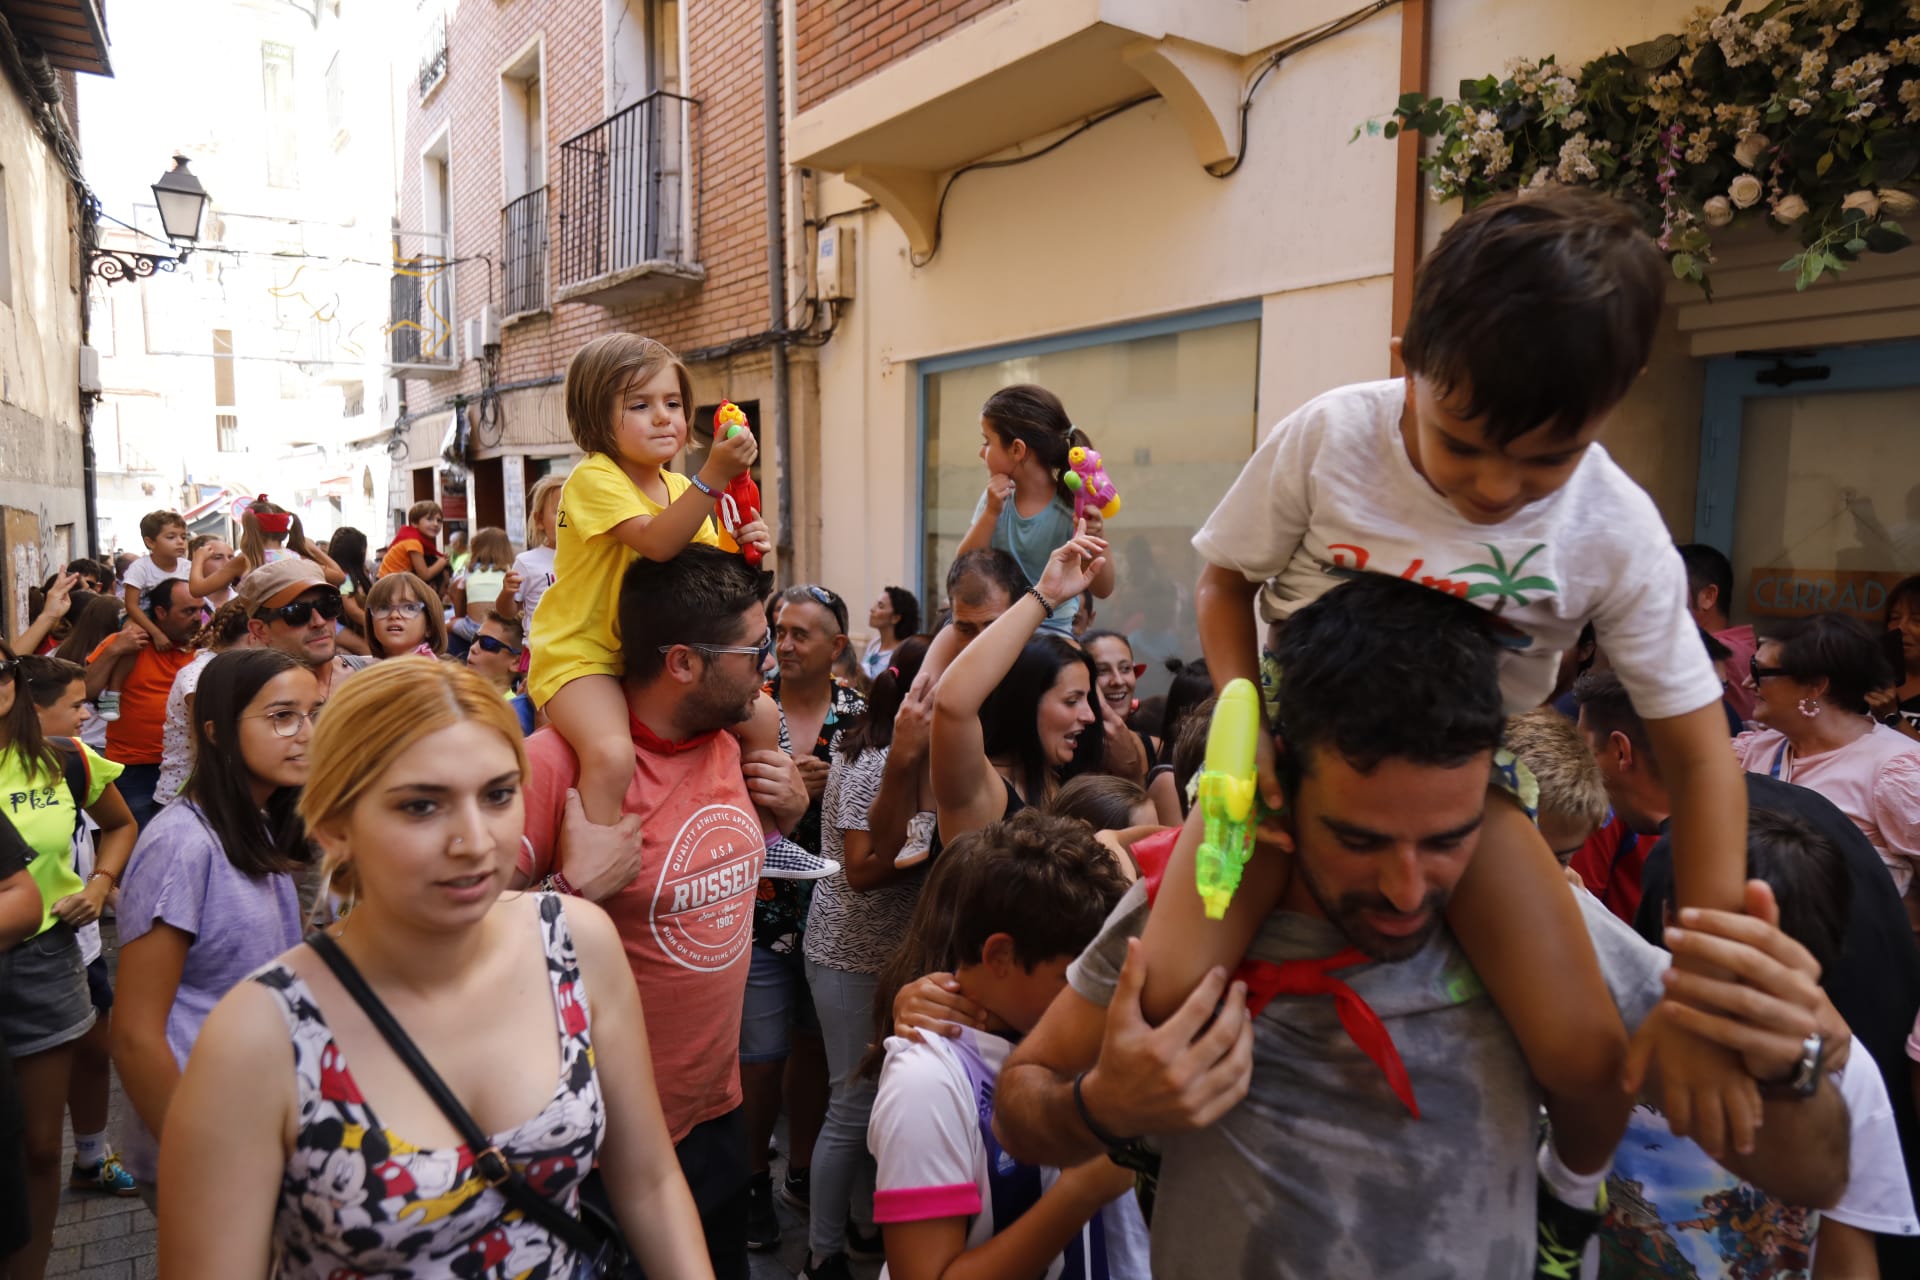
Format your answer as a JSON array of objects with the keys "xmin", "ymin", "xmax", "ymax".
[{"xmin": 388, "ymin": 0, "xmax": 818, "ymax": 566}]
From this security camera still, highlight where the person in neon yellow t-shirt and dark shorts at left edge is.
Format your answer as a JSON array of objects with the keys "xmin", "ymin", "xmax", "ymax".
[{"xmin": 0, "ymin": 645, "xmax": 134, "ymax": 1280}]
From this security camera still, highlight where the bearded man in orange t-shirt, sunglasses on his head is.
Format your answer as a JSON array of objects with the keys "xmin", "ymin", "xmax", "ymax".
[{"xmin": 86, "ymin": 578, "xmax": 207, "ymax": 827}]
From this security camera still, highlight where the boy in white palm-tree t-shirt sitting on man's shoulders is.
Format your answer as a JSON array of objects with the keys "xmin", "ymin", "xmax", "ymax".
[{"xmin": 1144, "ymin": 188, "xmax": 1759, "ymax": 1274}]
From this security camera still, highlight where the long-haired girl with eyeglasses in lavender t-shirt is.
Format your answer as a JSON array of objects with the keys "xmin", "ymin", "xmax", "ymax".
[{"xmin": 113, "ymin": 649, "xmax": 321, "ymax": 1203}]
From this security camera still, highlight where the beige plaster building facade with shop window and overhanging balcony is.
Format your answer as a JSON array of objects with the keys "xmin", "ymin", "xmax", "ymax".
[{"xmin": 787, "ymin": 0, "xmax": 1920, "ymax": 690}]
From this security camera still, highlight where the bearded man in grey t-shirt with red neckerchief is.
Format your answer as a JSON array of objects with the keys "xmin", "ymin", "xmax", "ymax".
[{"xmin": 995, "ymin": 576, "xmax": 1847, "ymax": 1280}]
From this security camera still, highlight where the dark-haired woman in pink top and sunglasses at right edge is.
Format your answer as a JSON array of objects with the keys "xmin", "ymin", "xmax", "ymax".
[{"xmin": 1734, "ymin": 614, "xmax": 1920, "ymax": 931}]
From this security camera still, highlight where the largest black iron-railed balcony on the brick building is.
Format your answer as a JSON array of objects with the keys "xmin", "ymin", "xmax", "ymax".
[{"xmin": 555, "ymin": 92, "xmax": 707, "ymax": 307}]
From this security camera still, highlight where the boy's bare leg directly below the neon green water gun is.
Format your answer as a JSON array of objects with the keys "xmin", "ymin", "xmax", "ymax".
[{"xmin": 1140, "ymin": 808, "xmax": 1292, "ymax": 1023}]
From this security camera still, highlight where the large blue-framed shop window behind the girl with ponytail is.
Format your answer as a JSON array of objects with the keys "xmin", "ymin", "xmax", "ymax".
[{"xmin": 922, "ymin": 317, "xmax": 1260, "ymax": 699}]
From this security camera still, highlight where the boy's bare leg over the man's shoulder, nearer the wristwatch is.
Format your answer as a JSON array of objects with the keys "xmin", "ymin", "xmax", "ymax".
[{"xmin": 1446, "ymin": 791, "xmax": 1632, "ymax": 1174}]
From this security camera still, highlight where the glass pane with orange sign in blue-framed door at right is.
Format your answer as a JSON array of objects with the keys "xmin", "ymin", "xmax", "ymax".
[{"xmin": 1732, "ymin": 388, "xmax": 1920, "ymax": 626}]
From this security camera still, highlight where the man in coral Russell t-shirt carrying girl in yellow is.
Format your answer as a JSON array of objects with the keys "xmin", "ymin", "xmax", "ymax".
[{"xmin": 516, "ymin": 545, "xmax": 808, "ymax": 1280}]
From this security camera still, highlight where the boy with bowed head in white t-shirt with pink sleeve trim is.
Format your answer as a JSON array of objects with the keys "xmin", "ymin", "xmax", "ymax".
[{"xmin": 875, "ymin": 810, "xmax": 1150, "ymax": 1280}]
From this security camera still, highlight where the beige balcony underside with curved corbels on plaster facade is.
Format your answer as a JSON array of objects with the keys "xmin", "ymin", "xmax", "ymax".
[{"xmin": 787, "ymin": 0, "xmax": 1352, "ymax": 255}]
